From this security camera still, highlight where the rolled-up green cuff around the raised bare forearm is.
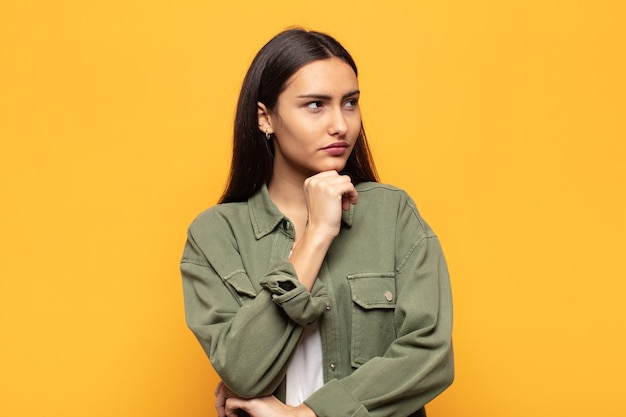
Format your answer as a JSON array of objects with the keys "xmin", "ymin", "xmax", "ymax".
[{"xmin": 260, "ymin": 261, "xmax": 330, "ymax": 326}]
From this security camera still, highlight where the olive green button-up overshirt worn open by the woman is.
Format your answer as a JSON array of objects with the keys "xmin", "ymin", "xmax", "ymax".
[{"xmin": 181, "ymin": 183, "xmax": 454, "ymax": 417}]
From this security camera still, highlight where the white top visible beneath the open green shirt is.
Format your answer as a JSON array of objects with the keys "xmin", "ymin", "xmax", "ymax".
[{"xmin": 285, "ymin": 322, "xmax": 324, "ymax": 407}]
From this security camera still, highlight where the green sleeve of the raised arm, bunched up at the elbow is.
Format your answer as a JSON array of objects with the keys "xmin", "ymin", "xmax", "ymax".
[{"xmin": 181, "ymin": 216, "xmax": 328, "ymax": 398}]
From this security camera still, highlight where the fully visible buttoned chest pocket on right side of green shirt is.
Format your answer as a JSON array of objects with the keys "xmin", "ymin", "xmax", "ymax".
[{"xmin": 347, "ymin": 272, "xmax": 396, "ymax": 368}]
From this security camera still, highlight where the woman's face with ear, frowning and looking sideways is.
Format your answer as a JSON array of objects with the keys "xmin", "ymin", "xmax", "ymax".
[{"xmin": 259, "ymin": 57, "xmax": 361, "ymax": 180}]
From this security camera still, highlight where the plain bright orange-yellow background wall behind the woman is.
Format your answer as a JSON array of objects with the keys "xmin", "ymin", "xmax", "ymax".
[{"xmin": 0, "ymin": 0, "xmax": 626, "ymax": 417}]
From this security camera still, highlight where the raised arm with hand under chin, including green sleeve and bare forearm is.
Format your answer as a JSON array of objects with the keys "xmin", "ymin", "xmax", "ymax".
[{"xmin": 181, "ymin": 171, "xmax": 357, "ymax": 398}]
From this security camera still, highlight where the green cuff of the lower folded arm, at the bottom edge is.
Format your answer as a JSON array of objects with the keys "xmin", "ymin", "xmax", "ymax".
[{"xmin": 304, "ymin": 379, "xmax": 370, "ymax": 417}]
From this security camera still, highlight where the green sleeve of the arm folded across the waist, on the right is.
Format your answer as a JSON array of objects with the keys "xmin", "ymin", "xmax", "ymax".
[{"xmin": 305, "ymin": 199, "xmax": 454, "ymax": 417}]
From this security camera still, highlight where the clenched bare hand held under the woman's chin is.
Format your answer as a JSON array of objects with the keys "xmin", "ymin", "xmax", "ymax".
[{"xmin": 304, "ymin": 171, "xmax": 358, "ymax": 239}]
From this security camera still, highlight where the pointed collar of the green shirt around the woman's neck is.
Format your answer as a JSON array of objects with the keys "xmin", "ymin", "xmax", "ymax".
[{"xmin": 248, "ymin": 185, "xmax": 354, "ymax": 239}]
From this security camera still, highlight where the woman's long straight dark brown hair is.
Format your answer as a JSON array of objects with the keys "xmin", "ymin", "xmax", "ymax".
[{"xmin": 220, "ymin": 28, "xmax": 378, "ymax": 203}]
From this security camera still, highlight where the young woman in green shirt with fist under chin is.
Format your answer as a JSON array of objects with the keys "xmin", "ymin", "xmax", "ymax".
[{"xmin": 181, "ymin": 29, "xmax": 453, "ymax": 417}]
